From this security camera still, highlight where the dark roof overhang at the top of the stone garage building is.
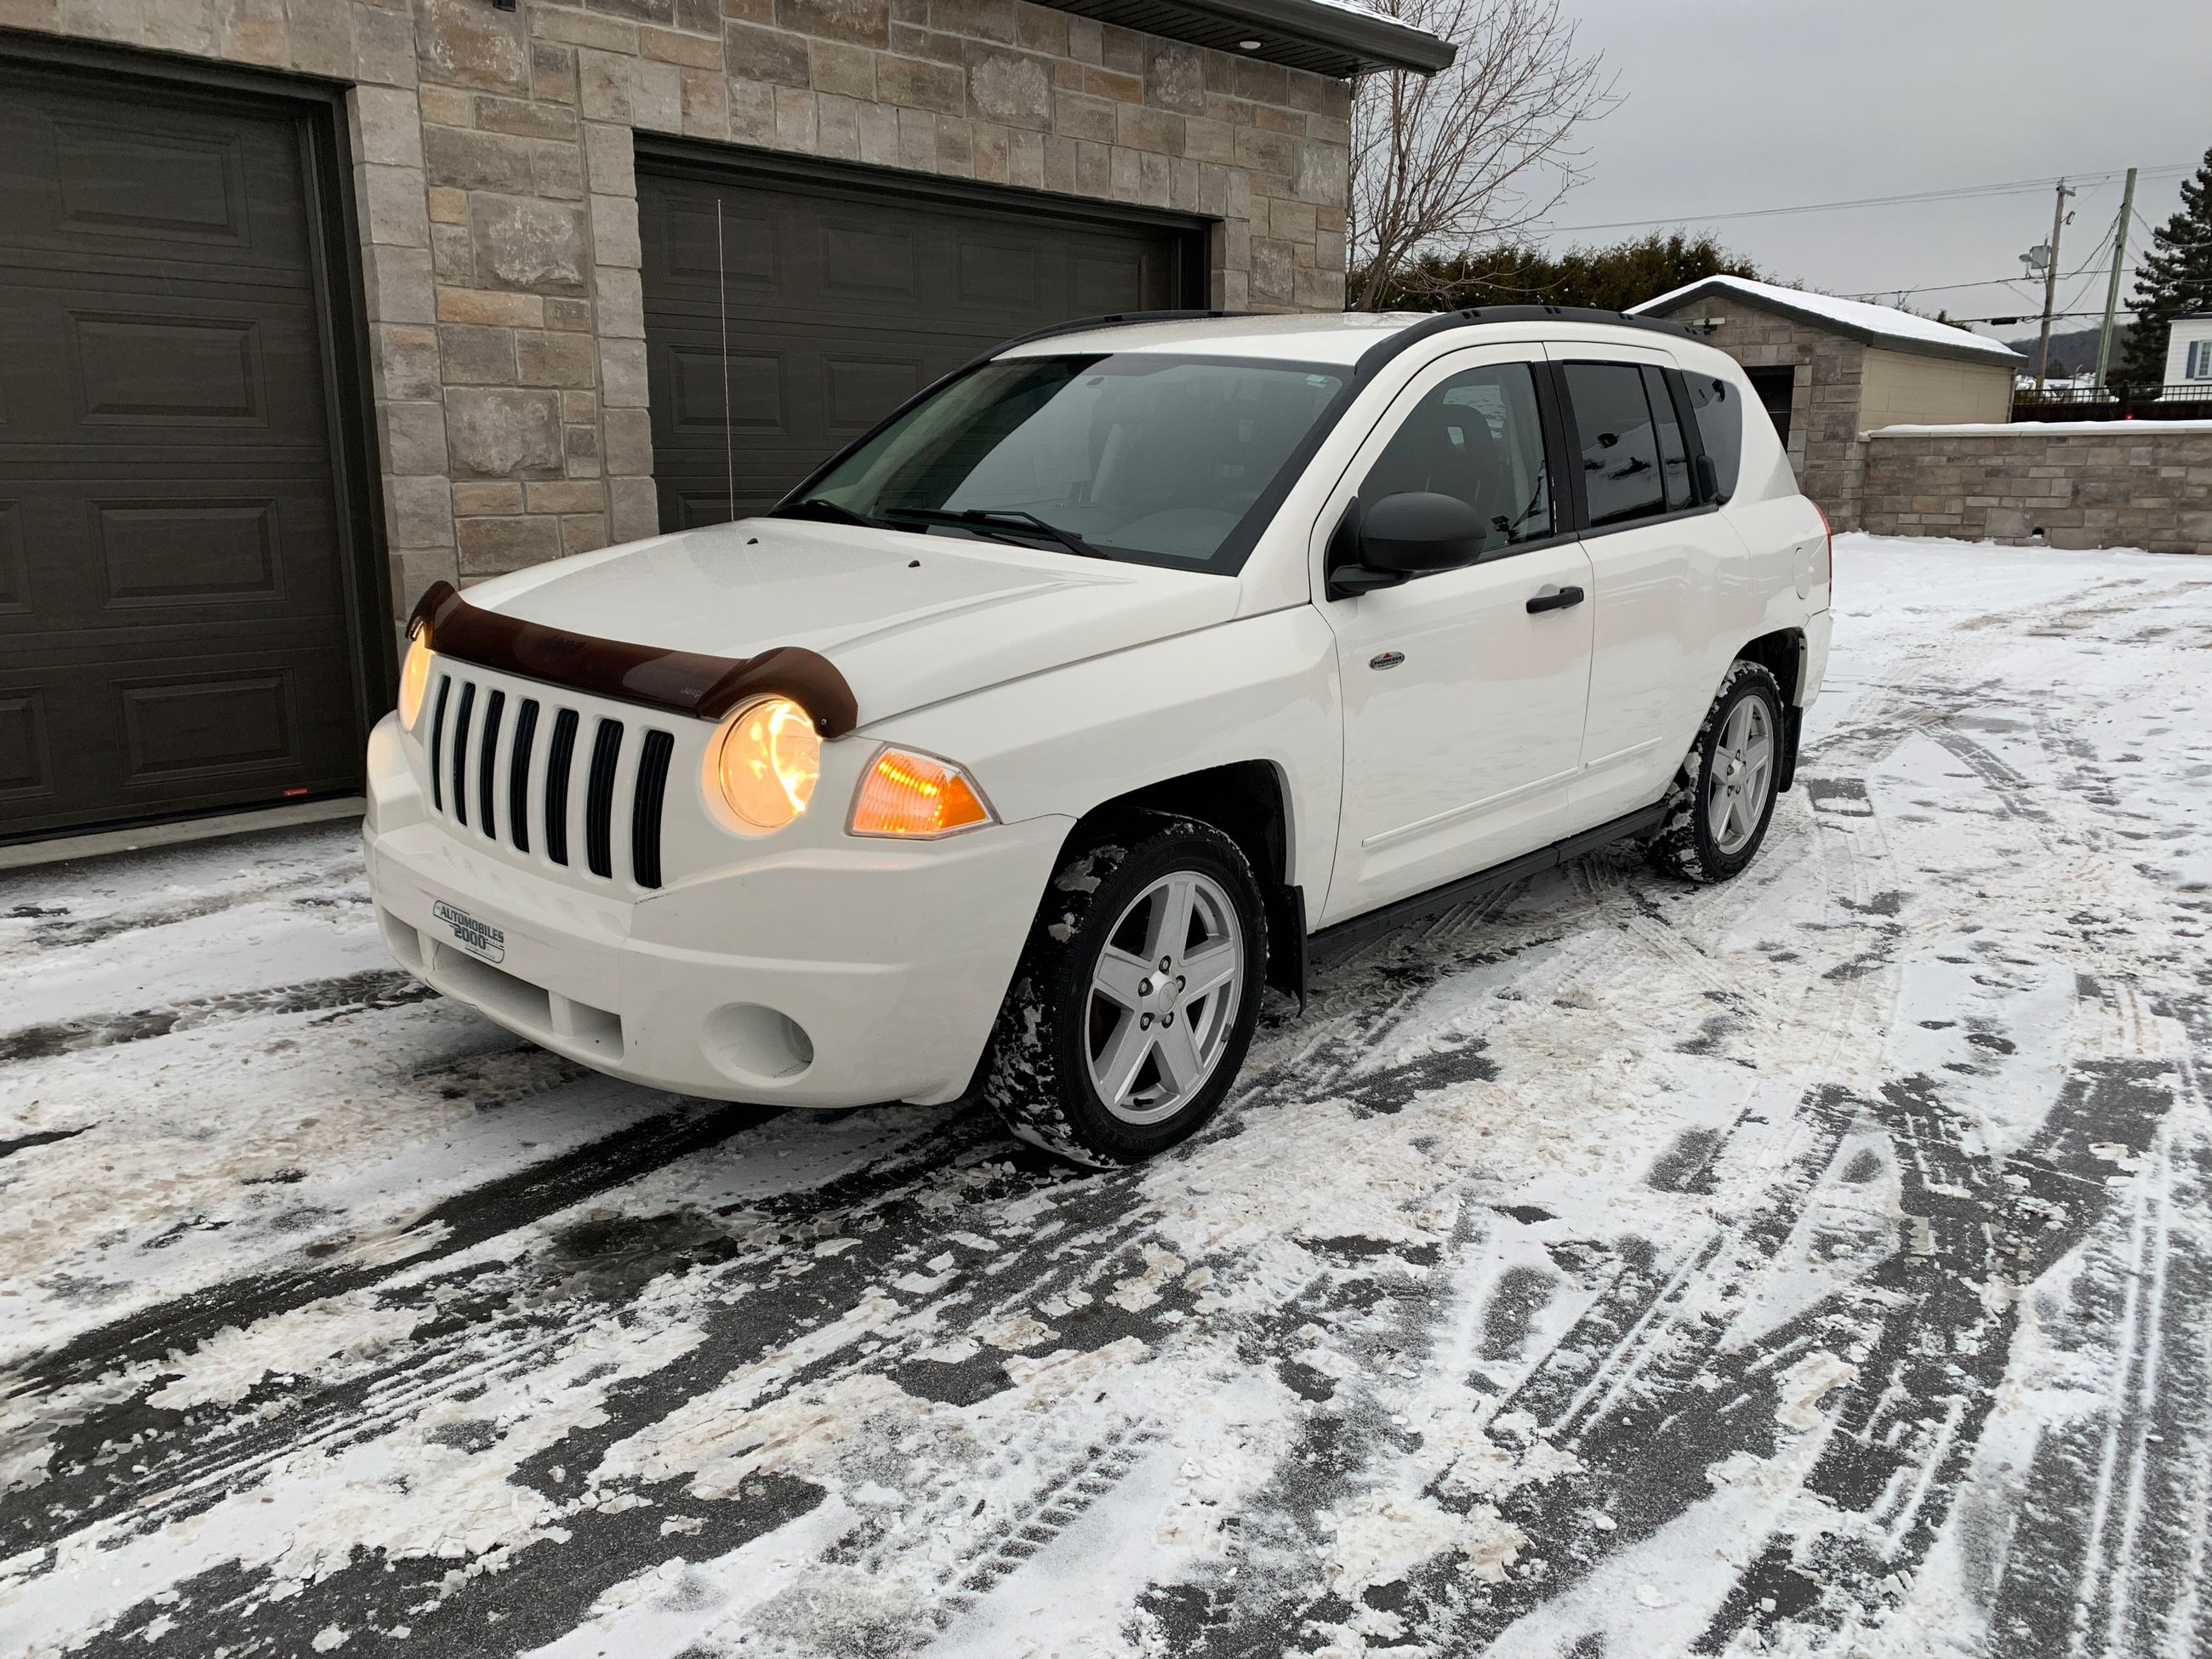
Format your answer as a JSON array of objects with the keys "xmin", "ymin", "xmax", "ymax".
[{"xmin": 1051, "ymin": 0, "xmax": 1457, "ymax": 80}]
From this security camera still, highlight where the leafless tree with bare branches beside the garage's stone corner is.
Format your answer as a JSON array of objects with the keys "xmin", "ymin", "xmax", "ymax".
[{"xmin": 1347, "ymin": 0, "xmax": 1612, "ymax": 310}]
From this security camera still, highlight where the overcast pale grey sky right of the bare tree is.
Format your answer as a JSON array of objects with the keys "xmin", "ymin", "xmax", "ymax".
[{"xmin": 1548, "ymin": 0, "xmax": 2212, "ymax": 336}]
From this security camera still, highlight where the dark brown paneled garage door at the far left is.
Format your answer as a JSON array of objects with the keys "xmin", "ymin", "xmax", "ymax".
[{"xmin": 0, "ymin": 64, "xmax": 361, "ymax": 841}]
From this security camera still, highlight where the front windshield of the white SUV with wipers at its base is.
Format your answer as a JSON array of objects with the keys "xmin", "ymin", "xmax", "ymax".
[{"xmin": 778, "ymin": 351, "xmax": 1345, "ymax": 573}]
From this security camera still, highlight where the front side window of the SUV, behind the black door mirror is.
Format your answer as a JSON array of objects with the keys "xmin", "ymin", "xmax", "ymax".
[{"xmin": 1358, "ymin": 362, "xmax": 1553, "ymax": 553}]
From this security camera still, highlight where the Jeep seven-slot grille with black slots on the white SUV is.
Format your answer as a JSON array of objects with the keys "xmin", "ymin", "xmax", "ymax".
[{"xmin": 427, "ymin": 672, "xmax": 675, "ymax": 887}]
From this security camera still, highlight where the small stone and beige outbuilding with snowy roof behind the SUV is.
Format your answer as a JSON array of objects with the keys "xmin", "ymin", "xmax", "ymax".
[{"xmin": 1633, "ymin": 276, "xmax": 2024, "ymax": 528}]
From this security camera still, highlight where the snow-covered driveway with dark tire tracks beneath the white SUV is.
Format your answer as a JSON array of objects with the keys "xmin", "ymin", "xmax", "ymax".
[{"xmin": 0, "ymin": 538, "xmax": 2212, "ymax": 1659}]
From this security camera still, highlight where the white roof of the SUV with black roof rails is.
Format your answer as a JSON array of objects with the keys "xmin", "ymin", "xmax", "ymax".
[{"xmin": 998, "ymin": 305, "xmax": 1688, "ymax": 365}]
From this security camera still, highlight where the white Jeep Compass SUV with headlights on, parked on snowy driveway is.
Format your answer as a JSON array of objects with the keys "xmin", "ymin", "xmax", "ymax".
[{"xmin": 368, "ymin": 307, "xmax": 1829, "ymax": 1164}]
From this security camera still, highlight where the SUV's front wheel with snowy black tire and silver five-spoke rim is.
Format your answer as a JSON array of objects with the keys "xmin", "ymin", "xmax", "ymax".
[{"xmin": 982, "ymin": 814, "xmax": 1268, "ymax": 1168}]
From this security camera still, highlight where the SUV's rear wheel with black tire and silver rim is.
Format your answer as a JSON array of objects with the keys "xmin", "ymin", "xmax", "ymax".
[{"xmin": 1648, "ymin": 661, "xmax": 1783, "ymax": 882}]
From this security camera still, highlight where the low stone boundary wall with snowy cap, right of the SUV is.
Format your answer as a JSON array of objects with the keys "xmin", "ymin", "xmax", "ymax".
[{"xmin": 1861, "ymin": 420, "xmax": 2212, "ymax": 553}]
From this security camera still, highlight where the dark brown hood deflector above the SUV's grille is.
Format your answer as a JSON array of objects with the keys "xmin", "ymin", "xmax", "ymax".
[{"xmin": 407, "ymin": 582, "xmax": 860, "ymax": 737}]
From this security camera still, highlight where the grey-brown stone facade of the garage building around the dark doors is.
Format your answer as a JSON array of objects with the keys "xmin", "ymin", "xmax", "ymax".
[{"xmin": 0, "ymin": 0, "xmax": 1349, "ymax": 615}]
